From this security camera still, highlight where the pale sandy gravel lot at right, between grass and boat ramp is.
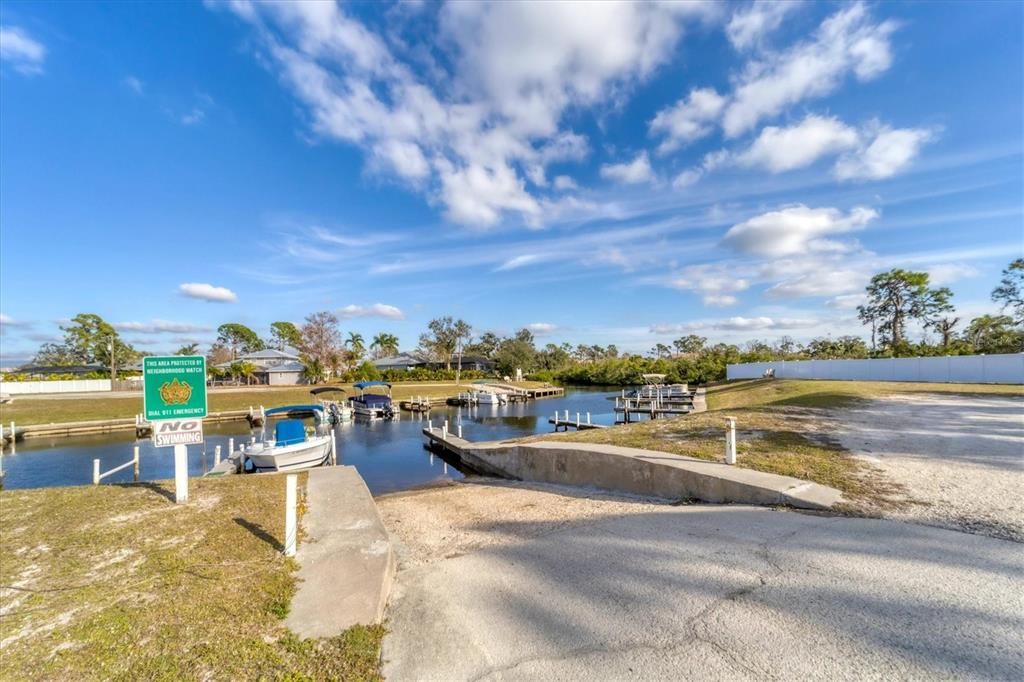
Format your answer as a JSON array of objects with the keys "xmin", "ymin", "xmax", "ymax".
[{"xmin": 835, "ymin": 394, "xmax": 1024, "ymax": 542}]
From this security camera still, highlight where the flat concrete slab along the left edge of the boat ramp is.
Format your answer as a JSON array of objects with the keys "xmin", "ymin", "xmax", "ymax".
[{"xmin": 285, "ymin": 466, "xmax": 395, "ymax": 637}]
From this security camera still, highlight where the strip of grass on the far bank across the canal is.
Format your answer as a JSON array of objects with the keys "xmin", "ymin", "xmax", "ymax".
[{"xmin": 0, "ymin": 382, "xmax": 552, "ymax": 426}]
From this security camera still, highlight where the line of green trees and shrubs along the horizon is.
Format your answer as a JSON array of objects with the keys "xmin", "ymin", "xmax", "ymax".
[{"xmin": 12, "ymin": 258, "xmax": 1024, "ymax": 384}]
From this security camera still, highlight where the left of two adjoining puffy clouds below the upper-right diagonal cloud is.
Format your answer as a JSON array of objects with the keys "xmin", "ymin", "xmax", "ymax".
[{"xmin": 736, "ymin": 115, "xmax": 858, "ymax": 173}]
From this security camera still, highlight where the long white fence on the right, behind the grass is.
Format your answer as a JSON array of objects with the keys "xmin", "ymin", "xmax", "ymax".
[{"xmin": 726, "ymin": 353, "xmax": 1024, "ymax": 384}]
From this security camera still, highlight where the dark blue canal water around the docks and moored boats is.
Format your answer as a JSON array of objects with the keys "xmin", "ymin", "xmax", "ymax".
[{"xmin": 3, "ymin": 389, "xmax": 617, "ymax": 495}]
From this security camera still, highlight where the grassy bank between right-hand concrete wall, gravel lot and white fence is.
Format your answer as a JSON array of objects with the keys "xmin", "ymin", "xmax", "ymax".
[{"xmin": 534, "ymin": 379, "xmax": 1022, "ymax": 507}]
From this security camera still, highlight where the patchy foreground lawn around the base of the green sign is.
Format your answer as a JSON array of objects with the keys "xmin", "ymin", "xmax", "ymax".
[{"xmin": 0, "ymin": 476, "xmax": 384, "ymax": 680}]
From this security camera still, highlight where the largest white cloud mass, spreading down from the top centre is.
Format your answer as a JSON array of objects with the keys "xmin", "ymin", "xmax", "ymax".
[{"xmin": 216, "ymin": 0, "xmax": 715, "ymax": 227}]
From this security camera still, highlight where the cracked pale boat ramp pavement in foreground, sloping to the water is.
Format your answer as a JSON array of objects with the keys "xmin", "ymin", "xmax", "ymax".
[{"xmin": 378, "ymin": 481, "xmax": 1024, "ymax": 682}]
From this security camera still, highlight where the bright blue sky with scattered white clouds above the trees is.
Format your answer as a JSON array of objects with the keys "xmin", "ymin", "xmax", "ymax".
[{"xmin": 0, "ymin": 0, "xmax": 1024, "ymax": 364}]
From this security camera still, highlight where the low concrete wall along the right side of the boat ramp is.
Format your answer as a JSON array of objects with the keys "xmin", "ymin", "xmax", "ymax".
[{"xmin": 423, "ymin": 428, "xmax": 843, "ymax": 509}]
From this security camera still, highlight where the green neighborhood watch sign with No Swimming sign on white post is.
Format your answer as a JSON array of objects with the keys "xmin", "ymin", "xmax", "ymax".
[{"xmin": 142, "ymin": 355, "xmax": 207, "ymax": 504}]
